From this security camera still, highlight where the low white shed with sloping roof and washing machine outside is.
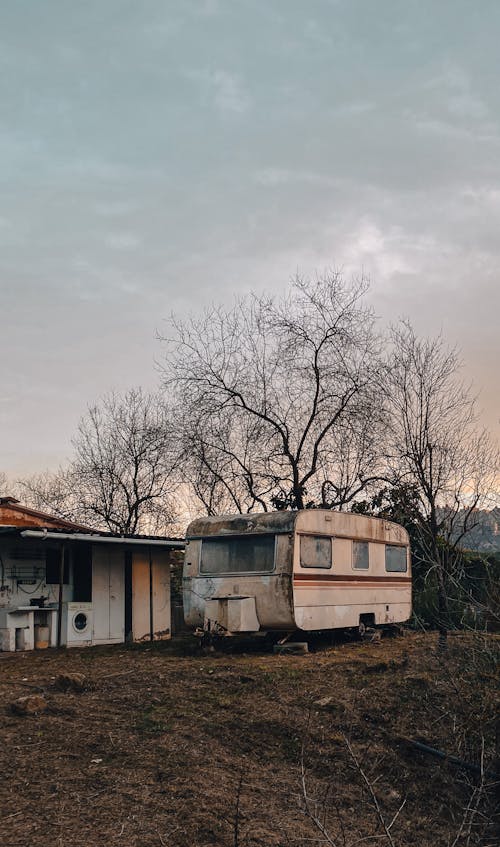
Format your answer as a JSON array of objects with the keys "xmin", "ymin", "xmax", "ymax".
[{"xmin": 0, "ymin": 497, "xmax": 184, "ymax": 651}]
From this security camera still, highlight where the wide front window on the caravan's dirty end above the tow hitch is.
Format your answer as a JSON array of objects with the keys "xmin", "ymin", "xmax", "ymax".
[{"xmin": 200, "ymin": 535, "xmax": 275, "ymax": 575}]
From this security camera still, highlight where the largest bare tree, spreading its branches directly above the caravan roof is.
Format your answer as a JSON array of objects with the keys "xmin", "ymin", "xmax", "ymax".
[{"xmin": 163, "ymin": 273, "xmax": 381, "ymax": 513}]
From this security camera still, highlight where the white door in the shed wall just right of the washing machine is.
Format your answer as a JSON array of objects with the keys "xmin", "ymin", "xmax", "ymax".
[{"xmin": 92, "ymin": 544, "xmax": 125, "ymax": 644}]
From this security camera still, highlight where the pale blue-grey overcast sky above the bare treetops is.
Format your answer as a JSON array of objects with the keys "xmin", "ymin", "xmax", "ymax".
[{"xmin": 0, "ymin": 0, "xmax": 500, "ymax": 476}]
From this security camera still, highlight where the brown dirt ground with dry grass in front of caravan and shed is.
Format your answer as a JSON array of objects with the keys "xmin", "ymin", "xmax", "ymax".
[{"xmin": 0, "ymin": 633, "xmax": 500, "ymax": 847}]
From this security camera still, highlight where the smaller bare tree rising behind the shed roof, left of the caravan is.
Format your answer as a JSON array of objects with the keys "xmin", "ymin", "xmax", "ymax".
[{"xmin": 19, "ymin": 389, "xmax": 176, "ymax": 533}]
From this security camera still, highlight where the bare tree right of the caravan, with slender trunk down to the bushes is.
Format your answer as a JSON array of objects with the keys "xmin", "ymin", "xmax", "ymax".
[{"xmin": 384, "ymin": 322, "xmax": 499, "ymax": 634}]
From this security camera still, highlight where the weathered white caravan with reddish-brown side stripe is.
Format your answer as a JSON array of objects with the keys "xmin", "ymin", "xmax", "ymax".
[{"xmin": 183, "ymin": 509, "xmax": 411, "ymax": 635}]
